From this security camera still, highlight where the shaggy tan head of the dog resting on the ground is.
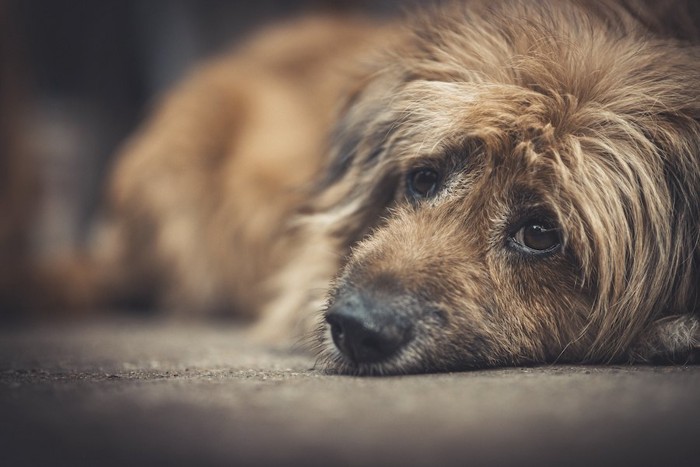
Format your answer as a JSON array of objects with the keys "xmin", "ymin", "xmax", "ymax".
[{"xmin": 308, "ymin": 2, "xmax": 700, "ymax": 374}]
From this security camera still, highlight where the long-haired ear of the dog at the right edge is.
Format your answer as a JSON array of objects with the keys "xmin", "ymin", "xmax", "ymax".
[{"xmin": 587, "ymin": 92, "xmax": 700, "ymax": 358}]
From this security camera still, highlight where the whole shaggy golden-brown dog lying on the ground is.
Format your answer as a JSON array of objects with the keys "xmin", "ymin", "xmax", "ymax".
[{"xmin": 43, "ymin": 0, "xmax": 700, "ymax": 374}]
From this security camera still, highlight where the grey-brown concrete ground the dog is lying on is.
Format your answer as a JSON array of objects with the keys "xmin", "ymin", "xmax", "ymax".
[{"xmin": 0, "ymin": 321, "xmax": 700, "ymax": 467}]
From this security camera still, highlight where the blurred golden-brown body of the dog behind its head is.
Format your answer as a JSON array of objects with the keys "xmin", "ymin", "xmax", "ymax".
[{"xmin": 0, "ymin": 16, "xmax": 391, "ymax": 322}]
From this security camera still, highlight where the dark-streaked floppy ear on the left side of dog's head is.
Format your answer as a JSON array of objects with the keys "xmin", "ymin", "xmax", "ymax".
[{"xmin": 303, "ymin": 72, "xmax": 408, "ymax": 246}]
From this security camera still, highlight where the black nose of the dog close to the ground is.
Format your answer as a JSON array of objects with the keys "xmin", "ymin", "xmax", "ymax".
[{"xmin": 326, "ymin": 294, "xmax": 412, "ymax": 363}]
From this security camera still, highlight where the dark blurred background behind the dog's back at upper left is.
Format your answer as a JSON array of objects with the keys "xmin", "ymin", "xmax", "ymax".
[{"xmin": 0, "ymin": 0, "xmax": 411, "ymax": 266}]
